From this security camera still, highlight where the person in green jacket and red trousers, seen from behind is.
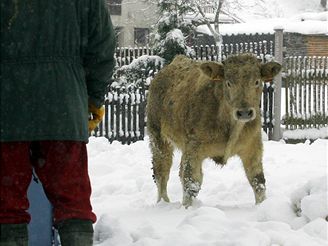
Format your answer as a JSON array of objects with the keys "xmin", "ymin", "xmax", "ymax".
[{"xmin": 0, "ymin": 0, "xmax": 116, "ymax": 246}]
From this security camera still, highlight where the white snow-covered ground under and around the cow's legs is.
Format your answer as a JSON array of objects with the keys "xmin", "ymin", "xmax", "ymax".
[{"xmin": 88, "ymin": 137, "xmax": 328, "ymax": 246}]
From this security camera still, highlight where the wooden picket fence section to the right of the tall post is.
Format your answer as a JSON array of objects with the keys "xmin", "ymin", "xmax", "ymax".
[{"xmin": 283, "ymin": 57, "xmax": 328, "ymax": 130}]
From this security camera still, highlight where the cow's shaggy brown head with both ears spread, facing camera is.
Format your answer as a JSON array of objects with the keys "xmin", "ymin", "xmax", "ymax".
[{"xmin": 200, "ymin": 54, "xmax": 281, "ymax": 122}]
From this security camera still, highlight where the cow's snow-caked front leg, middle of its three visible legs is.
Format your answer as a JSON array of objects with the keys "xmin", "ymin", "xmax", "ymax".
[{"xmin": 180, "ymin": 152, "xmax": 203, "ymax": 208}]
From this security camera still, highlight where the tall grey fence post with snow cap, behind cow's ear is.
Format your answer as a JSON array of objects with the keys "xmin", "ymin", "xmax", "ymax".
[{"xmin": 272, "ymin": 27, "xmax": 283, "ymax": 141}]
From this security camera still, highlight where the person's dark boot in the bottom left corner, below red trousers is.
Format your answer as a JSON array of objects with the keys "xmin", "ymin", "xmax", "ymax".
[{"xmin": 0, "ymin": 224, "xmax": 28, "ymax": 246}]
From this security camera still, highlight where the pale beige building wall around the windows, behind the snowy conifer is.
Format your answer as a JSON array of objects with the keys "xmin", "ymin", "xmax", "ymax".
[{"xmin": 111, "ymin": 0, "xmax": 158, "ymax": 47}]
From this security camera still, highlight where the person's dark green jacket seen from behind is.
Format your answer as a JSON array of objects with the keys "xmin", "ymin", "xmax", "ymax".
[{"xmin": 0, "ymin": 0, "xmax": 116, "ymax": 142}]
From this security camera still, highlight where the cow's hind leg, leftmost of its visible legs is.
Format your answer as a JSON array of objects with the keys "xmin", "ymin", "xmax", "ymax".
[{"xmin": 150, "ymin": 133, "xmax": 173, "ymax": 202}]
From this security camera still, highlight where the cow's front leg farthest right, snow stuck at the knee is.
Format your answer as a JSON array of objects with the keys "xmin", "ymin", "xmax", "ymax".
[{"xmin": 240, "ymin": 145, "xmax": 266, "ymax": 204}]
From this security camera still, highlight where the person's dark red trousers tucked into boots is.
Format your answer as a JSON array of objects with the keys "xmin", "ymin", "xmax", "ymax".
[{"xmin": 0, "ymin": 141, "xmax": 96, "ymax": 224}]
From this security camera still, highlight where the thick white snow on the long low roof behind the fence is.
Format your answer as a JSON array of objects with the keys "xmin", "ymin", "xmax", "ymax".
[{"xmin": 197, "ymin": 11, "xmax": 328, "ymax": 35}]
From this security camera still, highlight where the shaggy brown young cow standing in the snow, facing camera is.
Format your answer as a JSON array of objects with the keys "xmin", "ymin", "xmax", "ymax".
[{"xmin": 147, "ymin": 54, "xmax": 281, "ymax": 208}]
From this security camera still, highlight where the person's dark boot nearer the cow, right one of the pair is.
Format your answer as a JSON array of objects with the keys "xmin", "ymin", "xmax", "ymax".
[{"xmin": 56, "ymin": 219, "xmax": 93, "ymax": 246}]
